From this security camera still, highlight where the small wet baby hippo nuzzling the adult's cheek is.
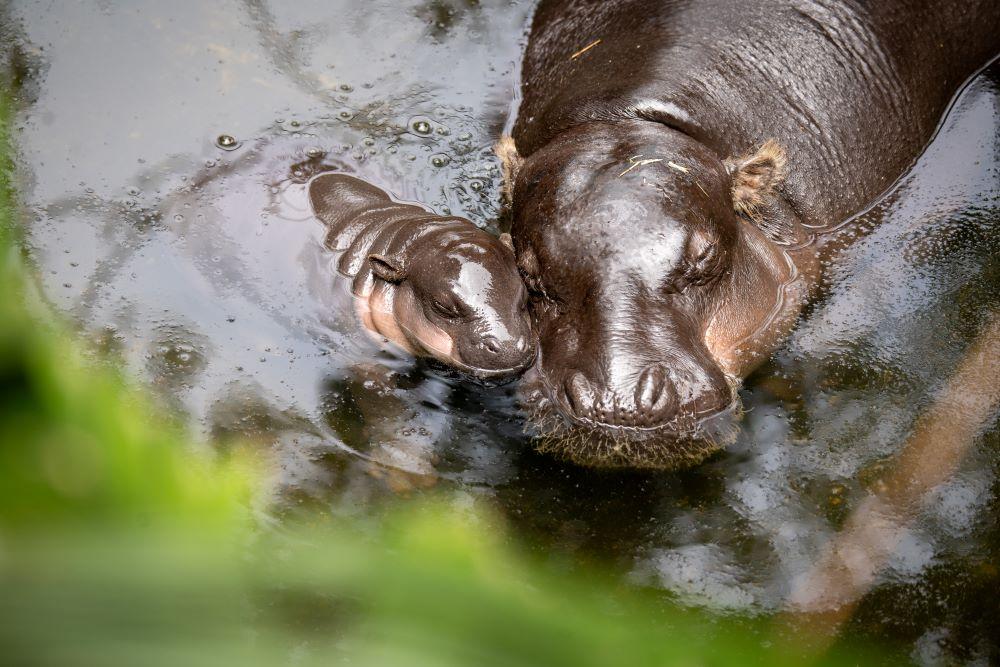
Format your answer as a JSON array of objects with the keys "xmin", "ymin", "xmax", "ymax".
[{"xmin": 309, "ymin": 173, "xmax": 535, "ymax": 379}]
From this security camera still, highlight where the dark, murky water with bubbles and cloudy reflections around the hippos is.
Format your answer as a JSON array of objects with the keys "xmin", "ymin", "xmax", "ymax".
[{"xmin": 0, "ymin": 0, "xmax": 1000, "ymax": 665}]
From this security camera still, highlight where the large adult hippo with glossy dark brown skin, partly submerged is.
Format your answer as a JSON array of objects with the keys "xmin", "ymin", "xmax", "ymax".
[{"xmin": 499, "ymin": 0, "xmax": 1000, "ymax": 468}]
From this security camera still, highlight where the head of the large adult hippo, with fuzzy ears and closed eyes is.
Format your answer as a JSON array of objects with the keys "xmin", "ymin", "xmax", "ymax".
[{"xmin": 499, "ymin": 121, "xmax": 795, "ymax": 468}]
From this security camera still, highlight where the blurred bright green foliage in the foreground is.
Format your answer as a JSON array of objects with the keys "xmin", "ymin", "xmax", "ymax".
[{"xmin": 0, "ymin": 90, "xmax": 876, "ymax": 667}]
